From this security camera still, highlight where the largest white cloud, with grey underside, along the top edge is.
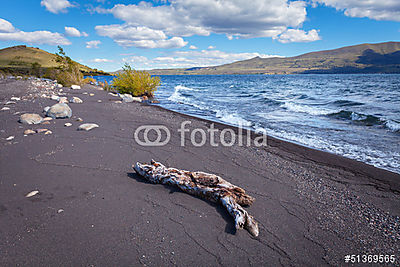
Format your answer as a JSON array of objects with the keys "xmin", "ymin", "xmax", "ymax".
[{"xmin": 102, "ymin": 0, "xmax": 306, "ymax": 38}]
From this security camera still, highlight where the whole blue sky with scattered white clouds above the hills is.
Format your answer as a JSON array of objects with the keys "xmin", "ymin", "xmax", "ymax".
[{"xmin": 0, "ymin": 0, "xmax": 400, "ymax": 71}]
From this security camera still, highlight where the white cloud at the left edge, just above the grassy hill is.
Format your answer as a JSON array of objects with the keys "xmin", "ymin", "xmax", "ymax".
[{"xmin": 0, "ymin": 19, "xmax": 71, "ymax": 45}]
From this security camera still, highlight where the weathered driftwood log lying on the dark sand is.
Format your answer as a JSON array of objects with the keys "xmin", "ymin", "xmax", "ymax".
[{"xmin": 133, "ymin": 160, "xmax": 258, "ymax": 236}]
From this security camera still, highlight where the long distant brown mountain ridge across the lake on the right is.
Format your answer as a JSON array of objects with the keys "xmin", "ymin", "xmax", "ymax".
[{"xmin": 150, "ymin": 42, "xmax": 400, "ymax": 75}]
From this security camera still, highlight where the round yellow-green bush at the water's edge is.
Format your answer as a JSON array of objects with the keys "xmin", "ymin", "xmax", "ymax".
[{"xmin": 113, "ymin": 64, "xmax": 160, "ymax": 97}]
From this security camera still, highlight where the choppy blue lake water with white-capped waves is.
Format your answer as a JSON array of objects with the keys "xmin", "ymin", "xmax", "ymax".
[{"xmin": 94, "ymin": 74, "xmax": 400, "ymax": 173}]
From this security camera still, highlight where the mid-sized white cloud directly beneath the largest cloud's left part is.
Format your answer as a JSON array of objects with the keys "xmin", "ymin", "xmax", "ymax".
[{"xmin": 95, "ymin": 24, "xmax": 187, "ymax": 48}]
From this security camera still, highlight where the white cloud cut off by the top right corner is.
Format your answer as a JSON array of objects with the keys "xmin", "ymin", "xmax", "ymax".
[{"xmin": 314, "ymin": 0, "xmax": 400, "ymax": 21}]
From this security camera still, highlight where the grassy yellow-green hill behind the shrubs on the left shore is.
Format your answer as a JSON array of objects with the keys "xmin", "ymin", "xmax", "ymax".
[{"xmin": 0, "ymin": 45, "xmax": 108, "ymax": 74}]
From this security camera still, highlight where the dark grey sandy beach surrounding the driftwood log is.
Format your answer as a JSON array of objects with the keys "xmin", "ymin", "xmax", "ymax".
[{"xmin": 0, "ymin": 77, "xmax": 400, "ymax": 266}]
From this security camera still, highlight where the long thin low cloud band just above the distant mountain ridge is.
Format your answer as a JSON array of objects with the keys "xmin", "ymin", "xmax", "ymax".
[{"xmin": 123, "ymin": 50, "xmax": 277, "ymax": 69}]
